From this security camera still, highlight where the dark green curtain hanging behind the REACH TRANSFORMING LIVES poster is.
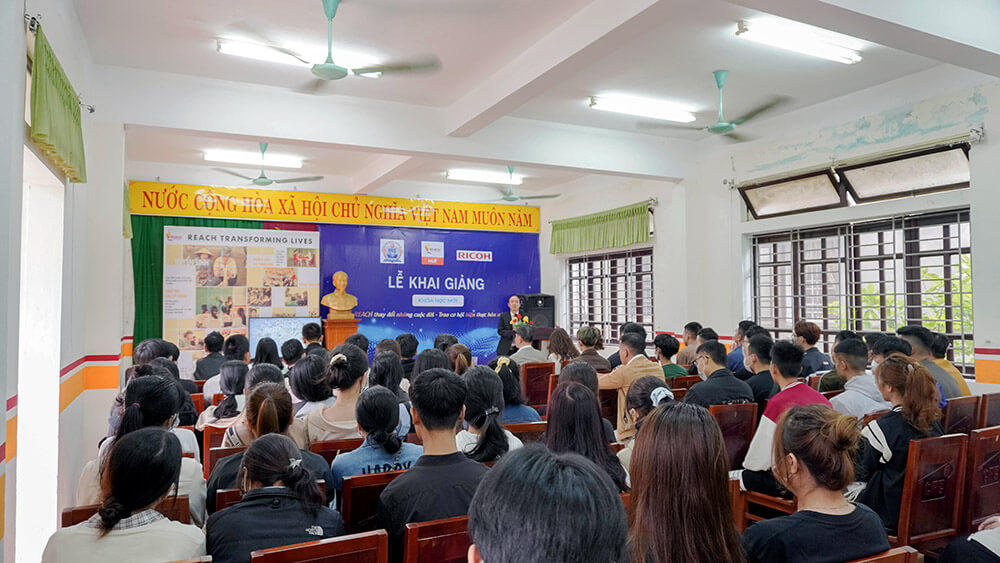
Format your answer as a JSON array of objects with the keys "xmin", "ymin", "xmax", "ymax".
[{"xmin": 132, "ymin": 215, "xmax": 263, "ymax": 344}]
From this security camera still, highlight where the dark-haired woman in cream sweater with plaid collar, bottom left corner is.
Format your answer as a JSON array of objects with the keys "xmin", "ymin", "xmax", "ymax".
[{"xmin": 42, "ymin": 430, "xmax": 205, "ymax": 563}]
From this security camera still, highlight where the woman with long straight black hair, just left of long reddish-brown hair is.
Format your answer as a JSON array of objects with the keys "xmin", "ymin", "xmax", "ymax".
[{"xmin": 545, "ymin": 383, "xmax": 628, "ymax": 492}]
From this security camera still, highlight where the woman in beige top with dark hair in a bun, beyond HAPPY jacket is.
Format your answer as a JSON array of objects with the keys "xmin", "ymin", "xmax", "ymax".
[{"xmin": 306, "ymin": 344, "xmax": 372, "ymax": 444}]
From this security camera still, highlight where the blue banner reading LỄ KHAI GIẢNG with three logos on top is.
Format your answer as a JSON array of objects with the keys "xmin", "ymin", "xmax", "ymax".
[{"xmin": 319, "ymin": 225, "xmax": 540, "ymax": 364}]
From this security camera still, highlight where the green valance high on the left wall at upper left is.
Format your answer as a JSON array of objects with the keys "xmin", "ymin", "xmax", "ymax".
[{"xmin": 31, "ymin": 27, "xmax": 87, "ymax": 183}]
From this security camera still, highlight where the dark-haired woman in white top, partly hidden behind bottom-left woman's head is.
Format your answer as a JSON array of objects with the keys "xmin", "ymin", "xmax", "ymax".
[{"xmin": 76, "ymin": 375, "xmax": 205, "ymax": 526}]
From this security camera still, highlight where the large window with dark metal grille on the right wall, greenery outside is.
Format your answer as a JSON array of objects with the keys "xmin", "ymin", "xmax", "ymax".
[{"xmin": 753, "ymin": 209, "xmax": 973, "ymax": 375}]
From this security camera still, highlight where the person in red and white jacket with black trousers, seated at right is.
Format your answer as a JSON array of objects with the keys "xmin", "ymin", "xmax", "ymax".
[{"xmin": 740, "ymin": 340, "xmax": 830, "ymax": 495}]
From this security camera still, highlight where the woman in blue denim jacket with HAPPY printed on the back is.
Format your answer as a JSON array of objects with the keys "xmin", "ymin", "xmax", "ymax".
[{"xmin": 330, "ymin": 390, "xmax": 424, "ymax": 501}]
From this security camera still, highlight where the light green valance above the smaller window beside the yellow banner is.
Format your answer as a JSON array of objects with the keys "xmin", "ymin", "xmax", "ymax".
[{"xmin": 549, "ymin": 201, "xmax": 649, "ymax": 254}]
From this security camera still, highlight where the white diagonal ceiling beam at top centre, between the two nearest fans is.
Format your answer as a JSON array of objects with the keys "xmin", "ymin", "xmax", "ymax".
[{"xmin": 446, "ymin": 0, "xmax": 686, "ymax": 137}]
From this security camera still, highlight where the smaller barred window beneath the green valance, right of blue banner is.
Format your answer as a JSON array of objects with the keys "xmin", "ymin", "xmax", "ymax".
[{"xmin": 569, "ymin": 248, "xmax": 653, "ymax": 343}]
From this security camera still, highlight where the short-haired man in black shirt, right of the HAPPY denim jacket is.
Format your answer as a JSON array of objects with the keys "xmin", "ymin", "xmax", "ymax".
[{"xmin": 376, "ymin": 368, "xmax": 487, "ymax": 561}]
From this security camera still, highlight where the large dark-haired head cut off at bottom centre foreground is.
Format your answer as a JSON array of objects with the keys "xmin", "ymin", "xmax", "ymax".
[{"xmin": 468, "ymin": 446, "xmax": 628, "ymax": 563}]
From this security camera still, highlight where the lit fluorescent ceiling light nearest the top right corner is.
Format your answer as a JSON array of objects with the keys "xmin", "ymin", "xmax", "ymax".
[{"xmin": 736, "ymin": 18, "xmax": 864, "ymax": 64}]
